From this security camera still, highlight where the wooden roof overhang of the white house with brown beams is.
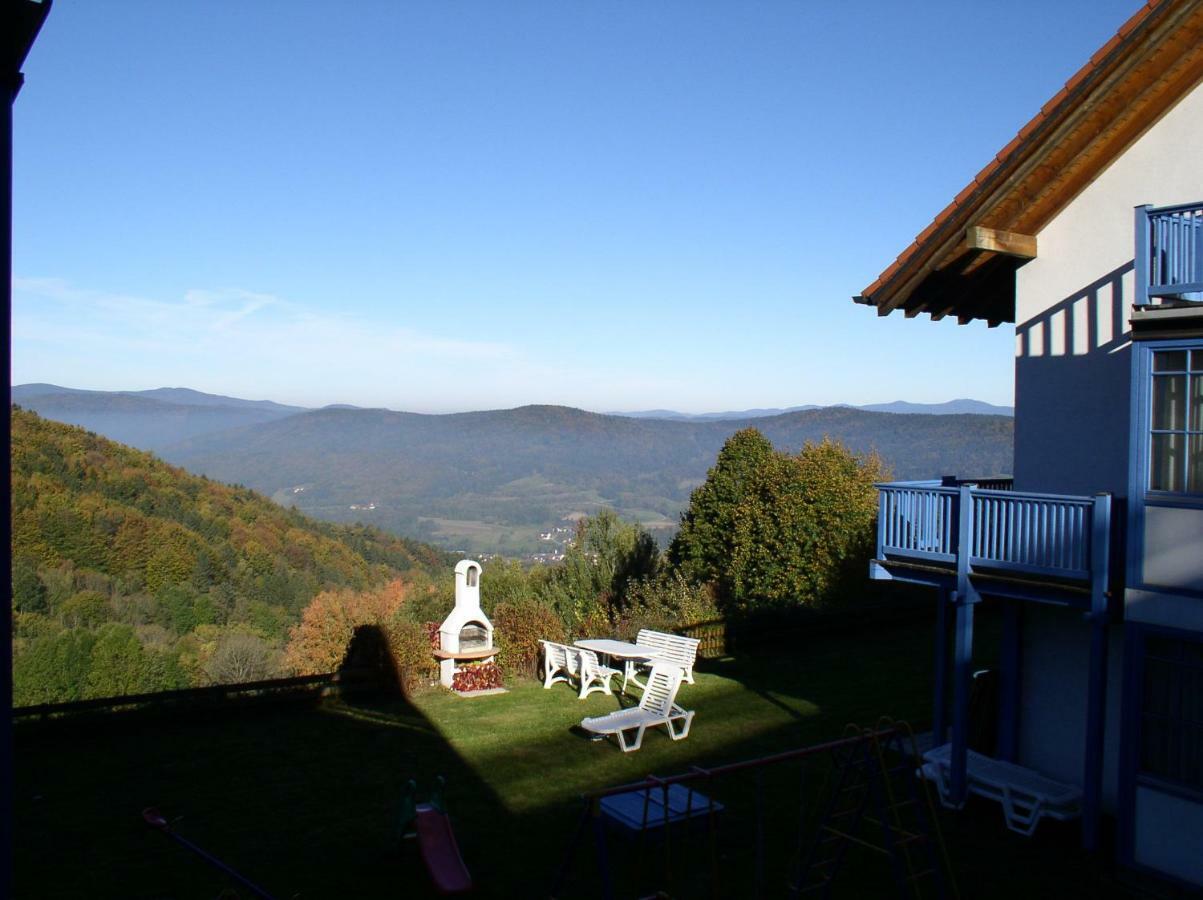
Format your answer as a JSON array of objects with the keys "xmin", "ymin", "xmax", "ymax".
[{"xmin": 853, "ymin": 0, "xmax": 1203, "ymax": 327}]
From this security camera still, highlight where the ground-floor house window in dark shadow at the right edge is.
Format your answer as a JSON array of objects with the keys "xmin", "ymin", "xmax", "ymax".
[{"xmin": 1140, "ymin": 636, "xmax": 1203, "ymax": 791}]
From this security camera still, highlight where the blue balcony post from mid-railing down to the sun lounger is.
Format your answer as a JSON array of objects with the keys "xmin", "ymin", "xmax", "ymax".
[{"xmin": 949, "ymin": 485, "xmax": 982, "ymax": 806}]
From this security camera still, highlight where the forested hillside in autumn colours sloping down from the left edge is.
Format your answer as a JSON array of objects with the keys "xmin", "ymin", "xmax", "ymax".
[{"xmin": 11, "ymin": 408, "xmax": 451, "ymax": 704}]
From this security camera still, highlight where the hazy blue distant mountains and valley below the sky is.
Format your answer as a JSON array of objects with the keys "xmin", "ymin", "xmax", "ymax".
[{"xmin": 13, "ymin": 385, "xmax": 1013, "ymax": 555}]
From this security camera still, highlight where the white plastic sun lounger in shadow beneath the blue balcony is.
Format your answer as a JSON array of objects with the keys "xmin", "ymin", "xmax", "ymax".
[{"xmin": 920, "ymin": 744, "xmax": 1081, "ymax": 835}]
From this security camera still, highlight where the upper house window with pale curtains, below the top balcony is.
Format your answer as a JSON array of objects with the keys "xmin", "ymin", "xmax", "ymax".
[{"xmin": 1149, "ymin": 349, "xmax": 1203, "ymax": 493}]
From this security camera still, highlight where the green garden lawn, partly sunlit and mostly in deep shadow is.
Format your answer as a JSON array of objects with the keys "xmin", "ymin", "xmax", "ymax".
[{"xmin": 13, "ymin": 622, "xmax": 1140, "ymax": 899}]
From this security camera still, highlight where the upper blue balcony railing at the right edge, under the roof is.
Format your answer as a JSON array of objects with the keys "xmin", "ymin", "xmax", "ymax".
[{"xmin": 1136, "ymin": 201, "xmax": 1203, "ymax": 306}]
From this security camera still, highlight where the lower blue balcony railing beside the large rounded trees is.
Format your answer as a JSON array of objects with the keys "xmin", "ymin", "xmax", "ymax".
[{"xmin": 877, "ymin": 481, "xmax": 1110, "ymax": 584}]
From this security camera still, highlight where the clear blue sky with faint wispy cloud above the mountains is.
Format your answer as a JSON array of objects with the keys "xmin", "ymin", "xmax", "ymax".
[{"xmin": 12, "ymin": 0, "xmax": 1138, "ymax": 411}]
